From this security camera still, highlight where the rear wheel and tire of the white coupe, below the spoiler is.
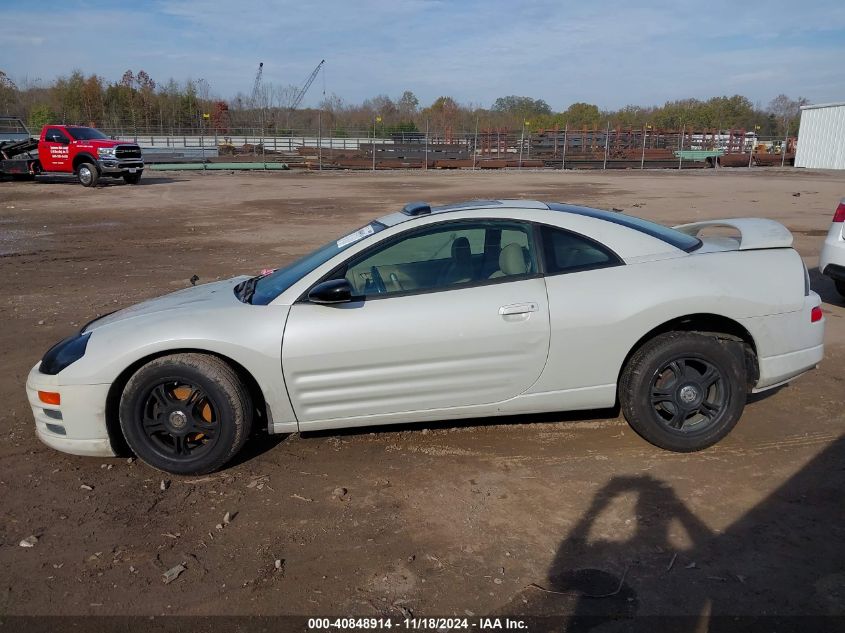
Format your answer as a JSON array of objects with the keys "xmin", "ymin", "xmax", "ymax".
[{"xmin": 619, "ymin": 332, "xmax": 748, "ymax": 453}]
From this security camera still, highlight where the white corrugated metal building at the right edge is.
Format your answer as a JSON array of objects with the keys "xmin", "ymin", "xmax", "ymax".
[{"xmin": 795, "ymin": 102, "xmax": 845, "ymax": 169}]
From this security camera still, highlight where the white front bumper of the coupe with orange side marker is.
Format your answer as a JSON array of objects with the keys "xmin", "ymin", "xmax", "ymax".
[{"xmin": 26, "ymin": 362, "xmax": 116, "ymax": 457}]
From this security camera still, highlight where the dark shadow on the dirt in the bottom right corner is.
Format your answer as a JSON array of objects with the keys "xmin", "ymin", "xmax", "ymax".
[{"xmin": 494, "ymin": 437, "xmax": 845, "ymax": 631}]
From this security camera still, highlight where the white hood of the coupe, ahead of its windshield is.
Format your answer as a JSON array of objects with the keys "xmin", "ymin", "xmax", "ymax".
[{"xmin": 83, "ymin": 275, "xmax": 249, "ymax": 332}]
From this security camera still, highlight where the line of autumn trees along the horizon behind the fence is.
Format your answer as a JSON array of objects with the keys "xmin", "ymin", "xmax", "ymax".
[{"xmin": 0, "ymin": 70, "xmax": 807, "ymax": 138}]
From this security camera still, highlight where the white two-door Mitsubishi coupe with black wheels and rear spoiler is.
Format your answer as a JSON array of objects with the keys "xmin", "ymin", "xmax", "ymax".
[{"xmin": 27, "ymin": 200, "xmax": 824, "ymax": 474}]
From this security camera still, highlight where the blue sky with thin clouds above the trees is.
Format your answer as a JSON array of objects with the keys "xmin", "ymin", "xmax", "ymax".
[{"xmin": 6, "ymin": 0, "xmax": 845, "ymax": 110}]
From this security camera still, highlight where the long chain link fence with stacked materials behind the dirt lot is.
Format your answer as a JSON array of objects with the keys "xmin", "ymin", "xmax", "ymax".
[{"xmin": 103, "ymin": 123, "xmax": 796, "ymax": 169}]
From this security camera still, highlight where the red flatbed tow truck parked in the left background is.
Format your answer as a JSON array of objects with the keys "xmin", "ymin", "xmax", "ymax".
[{"xmin": 0, "ymin": 117, "xmax": 144, "ymax": 187}]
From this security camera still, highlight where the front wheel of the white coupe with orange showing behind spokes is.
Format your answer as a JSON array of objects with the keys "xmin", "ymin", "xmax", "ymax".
[{"xmin": 120, "ymin": 354, "xmax": 253, "ymax": 475}]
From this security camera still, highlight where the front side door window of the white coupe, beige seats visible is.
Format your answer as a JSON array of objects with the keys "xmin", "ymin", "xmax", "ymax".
[{"xmin": 345, "ymin": 221, "xmax": 537, "ymax": 296}]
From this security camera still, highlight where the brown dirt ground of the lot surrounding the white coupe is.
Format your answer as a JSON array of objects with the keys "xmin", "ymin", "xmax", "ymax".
[{"xmin": 0, "ymin": 169, "xmax": 845, "ymax": 617}]
